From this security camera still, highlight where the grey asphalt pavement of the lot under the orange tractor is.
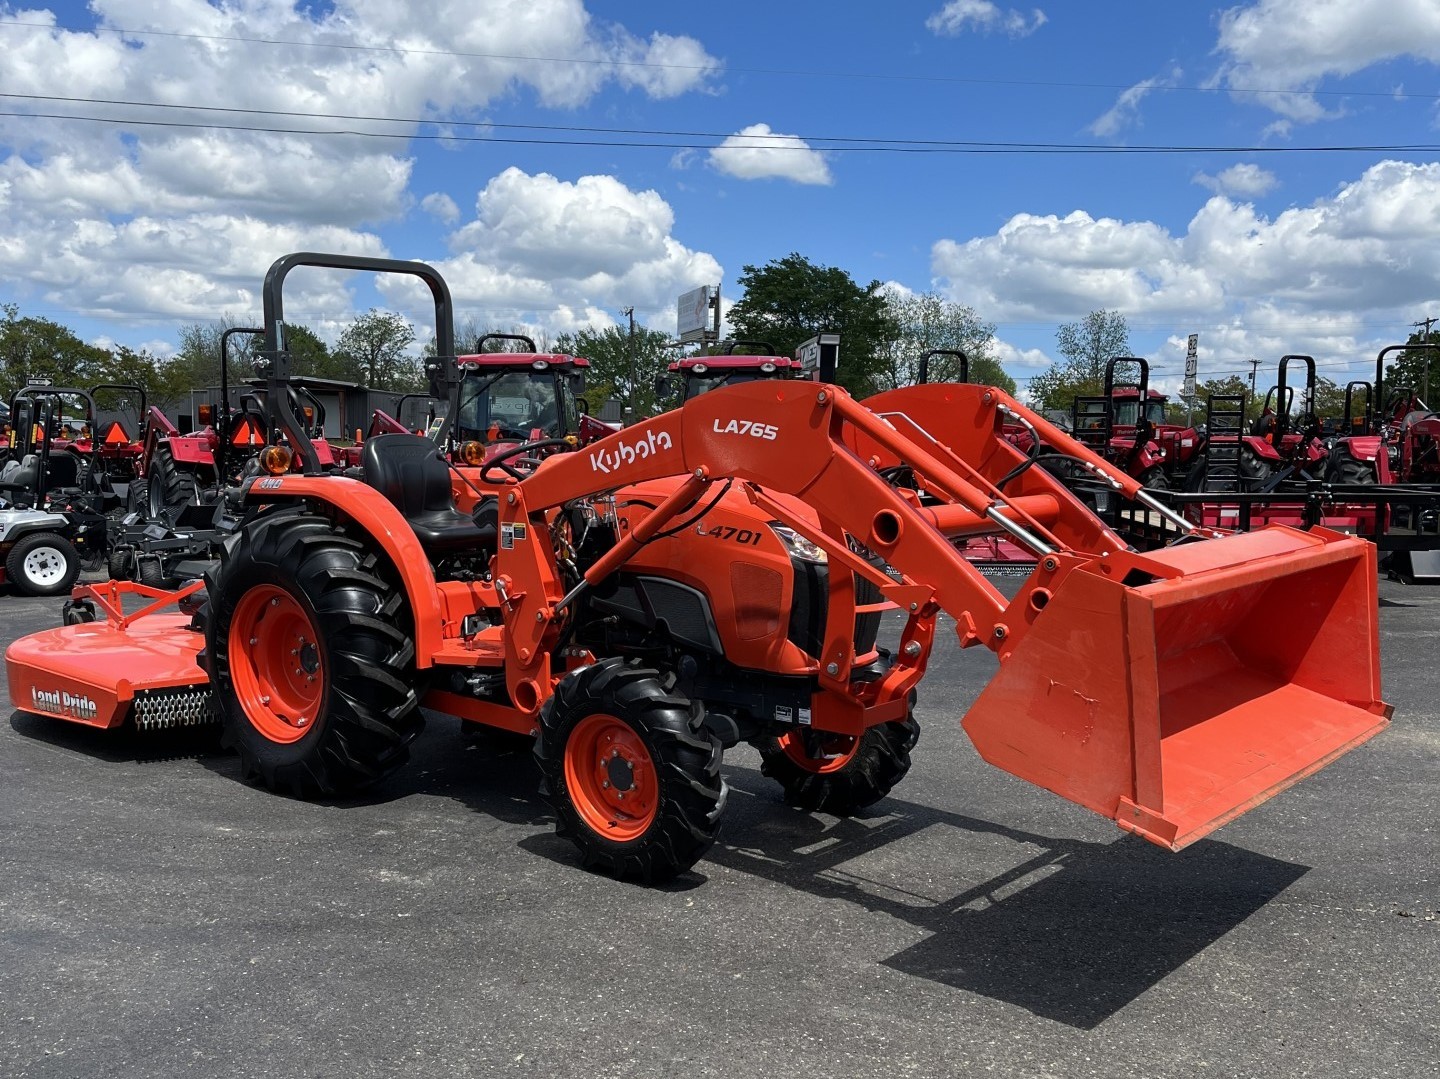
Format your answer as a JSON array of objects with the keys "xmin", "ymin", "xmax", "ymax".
[{"xmin": 0, "ymin": 581, "xmax": 1440, "ymax": 1079}]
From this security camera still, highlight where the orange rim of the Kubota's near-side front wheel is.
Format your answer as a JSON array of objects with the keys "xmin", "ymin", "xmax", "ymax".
[{"xmin": 564, "ymin": 715, "xmax": 660, "ymax": 843}]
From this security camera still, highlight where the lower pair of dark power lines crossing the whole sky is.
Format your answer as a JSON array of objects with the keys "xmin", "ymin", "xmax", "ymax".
[{"xmin": 0, "ymin": 94, "xmax": 1440, "ymax": 156}]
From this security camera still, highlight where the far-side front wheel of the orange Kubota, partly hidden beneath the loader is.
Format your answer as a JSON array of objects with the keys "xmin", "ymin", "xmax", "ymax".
[{"xmin": 756, "ymin": 715, "xmax": 920, "ymax": 817}]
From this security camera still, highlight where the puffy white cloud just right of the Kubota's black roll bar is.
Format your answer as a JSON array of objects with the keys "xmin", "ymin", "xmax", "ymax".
[{"xmin": 380, "ymin": 169, "xmax": 723, "ymax": 333}]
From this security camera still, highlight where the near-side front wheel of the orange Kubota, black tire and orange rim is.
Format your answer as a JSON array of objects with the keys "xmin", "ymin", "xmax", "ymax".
[{"xmin": 534, "ymin": 658, "xmax": 729, "ymax": 882}]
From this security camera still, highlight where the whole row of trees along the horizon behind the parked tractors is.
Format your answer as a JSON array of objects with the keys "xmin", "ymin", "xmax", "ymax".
[{"xmin": 0, "ymin": 252, "xmax": 1440, "ymax": 429}]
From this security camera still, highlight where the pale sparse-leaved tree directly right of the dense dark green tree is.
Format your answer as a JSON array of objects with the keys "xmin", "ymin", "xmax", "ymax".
[{"xmin": 864, "ymin": 288, "xmax": 1015, "ymax": 393}]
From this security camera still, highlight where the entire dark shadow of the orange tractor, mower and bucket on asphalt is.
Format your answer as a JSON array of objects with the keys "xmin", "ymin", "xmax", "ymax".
[{"xmin": 10, "ymin": 712, "xmax": 1309, "ymax": 1030}]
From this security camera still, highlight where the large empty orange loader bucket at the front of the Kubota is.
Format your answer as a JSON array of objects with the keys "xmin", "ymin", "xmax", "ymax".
[{"xmin": 963, "ymin": 527, "xmax": 1390, "ymax": 850}]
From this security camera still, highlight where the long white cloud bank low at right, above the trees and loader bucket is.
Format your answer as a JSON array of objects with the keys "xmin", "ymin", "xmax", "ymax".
[{"xmin": 932, "ymin": 161, "xmax": 1440, "ymax": 369}]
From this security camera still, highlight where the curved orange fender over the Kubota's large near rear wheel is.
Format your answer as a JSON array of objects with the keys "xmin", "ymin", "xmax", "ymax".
[{"xmin": 243, "ymin": 474, "xmax": 445, "ymax": 659}]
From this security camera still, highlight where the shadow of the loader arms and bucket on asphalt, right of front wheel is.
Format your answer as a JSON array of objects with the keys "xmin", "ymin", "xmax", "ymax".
[{"xmin": 701, "ymin": 768, "xmax": 1309, "ymax": 1030}]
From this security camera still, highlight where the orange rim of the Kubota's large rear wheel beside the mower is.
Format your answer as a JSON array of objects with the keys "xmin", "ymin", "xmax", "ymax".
[{"xmin": 229, "ymin": 585, "xmax": 325, "ymax": 742}]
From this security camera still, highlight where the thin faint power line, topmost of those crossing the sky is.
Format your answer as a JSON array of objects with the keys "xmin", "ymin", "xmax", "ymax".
[{"xmin": 0, "ymin": 22, "xmax": 1440, "ymax": 101}]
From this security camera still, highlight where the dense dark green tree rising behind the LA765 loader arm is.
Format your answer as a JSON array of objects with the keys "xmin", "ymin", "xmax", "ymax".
[{"xmin": 727, "ymin": 254, "xmax": 900, "ymax": 396}]
